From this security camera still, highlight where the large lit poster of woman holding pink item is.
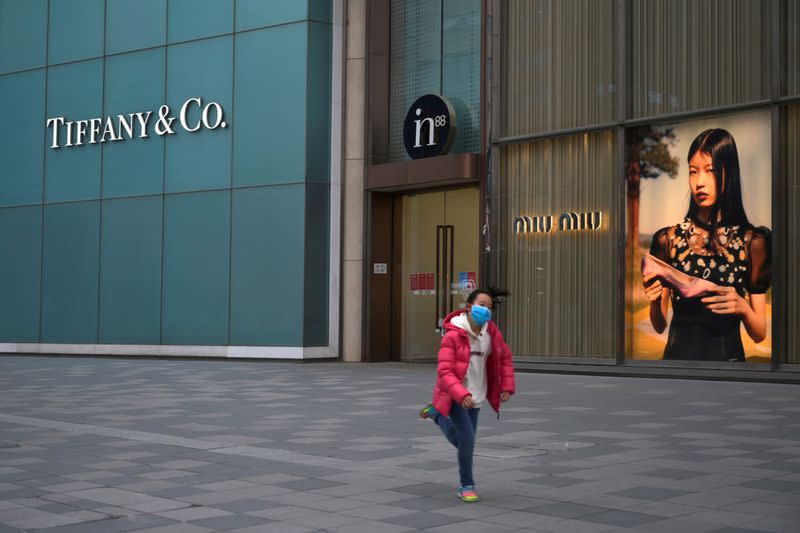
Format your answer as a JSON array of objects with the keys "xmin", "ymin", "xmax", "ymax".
[{"xmin": 626, "ymin": 111, "xmax": 772, "ymax": 363}]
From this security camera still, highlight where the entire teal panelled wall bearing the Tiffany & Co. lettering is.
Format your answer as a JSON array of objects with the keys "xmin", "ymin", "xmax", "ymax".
[{"xmin": 0, "ymin": 0, "xmax": 333, "ymax": 347}]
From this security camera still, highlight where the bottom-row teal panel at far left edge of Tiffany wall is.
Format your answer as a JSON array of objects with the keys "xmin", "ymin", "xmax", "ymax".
[{"xmin": 0, "ymin": 205, "xmax": 42, "ymax": 342}]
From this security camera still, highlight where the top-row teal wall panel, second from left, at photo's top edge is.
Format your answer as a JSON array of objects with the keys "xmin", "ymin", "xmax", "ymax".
[{"xmin": 47, "ymin": 0, "xmax": 106, "ymax": 65}]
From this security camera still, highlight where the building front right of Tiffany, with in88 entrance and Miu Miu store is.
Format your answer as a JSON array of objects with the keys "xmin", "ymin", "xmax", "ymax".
[{"xmin": 365, "ymin": 0, "xmax": 800, "ymax": 377}]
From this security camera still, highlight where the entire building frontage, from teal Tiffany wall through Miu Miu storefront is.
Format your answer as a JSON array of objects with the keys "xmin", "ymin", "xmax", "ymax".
[{"xmin": 0, "ymin": 0, "xmax": 800, "ymax": 379}]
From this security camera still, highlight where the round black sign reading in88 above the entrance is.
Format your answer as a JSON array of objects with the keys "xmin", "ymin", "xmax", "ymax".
[{"xmin": 403, "ymin": 94, "xmax": 456, "ymax": 159}]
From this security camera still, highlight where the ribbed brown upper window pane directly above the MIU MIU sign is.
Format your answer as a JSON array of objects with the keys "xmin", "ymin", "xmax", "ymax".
[{"xmin": 503, "ymin": 0, "xmax": 617, "ymax": 136}]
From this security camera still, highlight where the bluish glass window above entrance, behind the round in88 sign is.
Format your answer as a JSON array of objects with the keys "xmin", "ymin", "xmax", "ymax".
[{"xmin": 389, "ymin": 0, "xmax": 481, "ymax": 161}]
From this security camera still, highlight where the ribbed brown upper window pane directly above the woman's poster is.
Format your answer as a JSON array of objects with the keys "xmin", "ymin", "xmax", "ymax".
[{"xmin": 629, "ymin": 0, "xmax": 768, "ymax": 117}]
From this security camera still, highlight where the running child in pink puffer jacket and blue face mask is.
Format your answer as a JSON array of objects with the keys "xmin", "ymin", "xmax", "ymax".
[{"xmin": 419, "ymin": 289, "xmax": 515, "ymax": 503}]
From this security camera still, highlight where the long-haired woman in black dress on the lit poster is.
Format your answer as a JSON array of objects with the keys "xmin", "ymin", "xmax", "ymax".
[{"xmin": 643, "ymin": 128, "xmax": 771, "ymax": 361}]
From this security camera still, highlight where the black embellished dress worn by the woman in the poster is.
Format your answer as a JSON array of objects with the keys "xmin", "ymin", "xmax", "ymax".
[{"xmin": 650, "ymin": 218, "xmax": 771, "ymax": 361}]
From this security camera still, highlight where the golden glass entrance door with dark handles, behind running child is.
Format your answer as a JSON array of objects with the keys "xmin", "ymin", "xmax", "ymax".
[{"xmin": 400, "ymin": 187, "xmax": 480, "ymax": 360}]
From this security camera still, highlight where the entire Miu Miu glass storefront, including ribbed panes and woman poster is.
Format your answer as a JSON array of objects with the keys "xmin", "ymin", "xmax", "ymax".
[{"xmin": 491, "ymin": 0, "xmax": 788, "ymax": 367}]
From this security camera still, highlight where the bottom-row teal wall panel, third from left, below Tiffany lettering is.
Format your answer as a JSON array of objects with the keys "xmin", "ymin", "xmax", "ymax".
[{"xmin": 99, "ymin": 196, "xmax": 163, "ymax": 344}]
